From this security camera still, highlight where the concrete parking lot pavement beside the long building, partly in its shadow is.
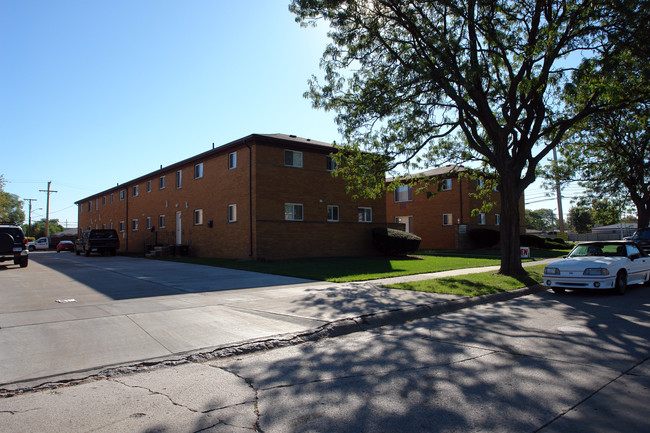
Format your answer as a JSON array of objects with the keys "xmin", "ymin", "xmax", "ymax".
[{"xmin": 0, "ymin": 252, "xmax": 455, "ymax": 389}]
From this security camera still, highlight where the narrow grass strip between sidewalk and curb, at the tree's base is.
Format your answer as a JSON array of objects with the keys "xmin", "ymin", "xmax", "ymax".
[{"xmin": 387, "ymin": 265, "xmax": 544, "ymax": 296}]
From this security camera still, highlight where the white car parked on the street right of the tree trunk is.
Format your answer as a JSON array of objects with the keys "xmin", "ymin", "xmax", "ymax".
[{"xmin": 543, "ymin": 241, "xmax": 650, "ymax": 295}]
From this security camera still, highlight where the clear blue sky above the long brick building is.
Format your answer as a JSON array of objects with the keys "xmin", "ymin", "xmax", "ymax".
[{"xmin": 0, "ymin": 0, "xmax": 568, "ymax": 227}]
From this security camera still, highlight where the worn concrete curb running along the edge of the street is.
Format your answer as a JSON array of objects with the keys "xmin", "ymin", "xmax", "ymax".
[{"xmin": 0, "ymin": 284, "xmax": 547, "ymax": 398}]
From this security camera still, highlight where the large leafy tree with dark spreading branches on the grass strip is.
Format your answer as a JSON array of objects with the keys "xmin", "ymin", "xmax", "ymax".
[{"xmin": 290, "ymin": 0, "xmax": 640, "ymax": 275}]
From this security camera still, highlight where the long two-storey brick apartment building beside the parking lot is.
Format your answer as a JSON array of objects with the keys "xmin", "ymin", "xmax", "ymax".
[{"xmin": 76, "ymin": 134, "xmax": 386, "ymax": 260}]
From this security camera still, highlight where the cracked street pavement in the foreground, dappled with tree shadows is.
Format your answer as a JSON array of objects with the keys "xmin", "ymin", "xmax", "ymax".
[{"xmin": 0, "ymin": 251, "xmax": 650, "ymax": 432}]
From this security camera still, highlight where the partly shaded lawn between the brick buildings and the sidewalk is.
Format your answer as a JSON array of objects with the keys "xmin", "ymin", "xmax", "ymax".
[{"xmin": 153, "ymin": 250, "xmax": 567, "ymax": 283}]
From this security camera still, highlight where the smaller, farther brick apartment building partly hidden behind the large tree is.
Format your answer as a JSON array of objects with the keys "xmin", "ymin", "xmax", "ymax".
[{"xmin": 386, "ymin": 166, "xmax": 525, "ymax": 249}]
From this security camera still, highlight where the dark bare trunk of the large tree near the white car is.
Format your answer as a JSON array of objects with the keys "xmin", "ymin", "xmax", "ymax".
[{"xmin": 499, "ymin": 176, "xmax": 525, "ymax": 276}]
